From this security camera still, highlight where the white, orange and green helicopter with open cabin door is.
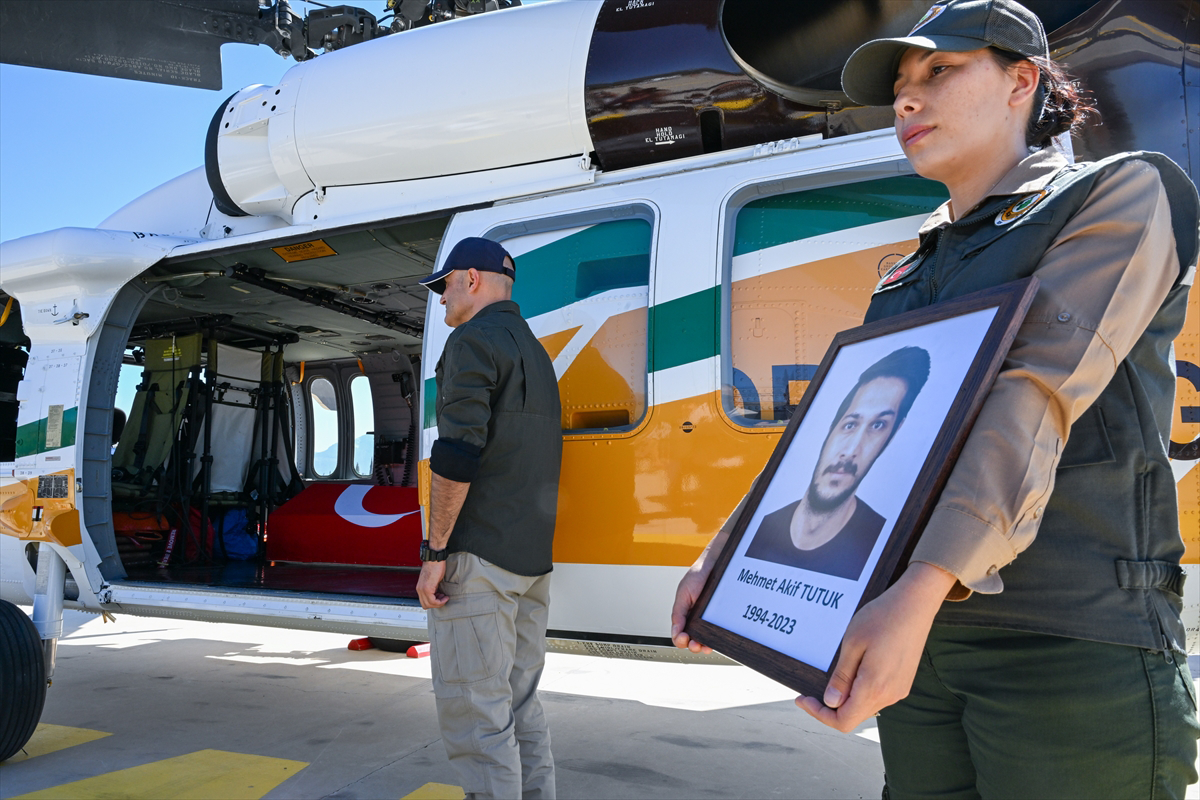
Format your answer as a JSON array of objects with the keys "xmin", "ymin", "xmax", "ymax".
[{"xmin": 0, "ymin": 0, "xmax": 1200, "ymax": 760}]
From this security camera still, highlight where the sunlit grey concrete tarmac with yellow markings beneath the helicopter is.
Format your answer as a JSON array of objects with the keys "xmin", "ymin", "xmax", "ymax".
[{"xmin": 0, "ymin": 609, "xmax": 883, "ymax": 800}]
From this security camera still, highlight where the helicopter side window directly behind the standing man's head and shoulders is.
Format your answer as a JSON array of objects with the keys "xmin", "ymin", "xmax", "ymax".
[{"xmin": 493, "ymin": 207, "xmax": 654, "ymax": 431}]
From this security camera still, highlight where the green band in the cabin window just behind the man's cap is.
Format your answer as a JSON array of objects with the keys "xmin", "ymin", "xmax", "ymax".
[{"xmin": 512, "ymin": 219, "xmax": 653, "ymax": 319}]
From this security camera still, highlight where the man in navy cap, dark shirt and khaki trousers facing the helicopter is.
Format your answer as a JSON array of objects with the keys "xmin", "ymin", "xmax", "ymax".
[{"xmin": 416, "ymin": 237, "xmax": 563, "ymax": 798}]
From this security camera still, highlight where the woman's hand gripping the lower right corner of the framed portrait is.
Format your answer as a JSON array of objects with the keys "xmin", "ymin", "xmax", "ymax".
[{"xmin": 796, "ymin": 561, "xmax": 955, "ymax": 733}]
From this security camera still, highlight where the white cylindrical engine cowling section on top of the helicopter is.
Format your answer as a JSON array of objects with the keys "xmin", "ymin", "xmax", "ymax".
[{"xmin": 205, "ymin": 0, "xmax": 602, "ymax": 222}]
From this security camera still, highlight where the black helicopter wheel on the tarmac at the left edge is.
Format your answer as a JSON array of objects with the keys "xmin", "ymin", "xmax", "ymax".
[{"xmin": 0, "ymin": 600, "xmax": 46, "ymax": 762}]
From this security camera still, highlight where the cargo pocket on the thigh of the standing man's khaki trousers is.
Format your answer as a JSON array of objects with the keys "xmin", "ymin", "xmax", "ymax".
[{"xmin": 430, "ymin": 593, "xmax": 504, "ymax": 685}]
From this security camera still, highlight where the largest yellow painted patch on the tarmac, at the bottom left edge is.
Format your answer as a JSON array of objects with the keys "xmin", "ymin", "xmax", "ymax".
[{"xmin": 13, "ymin": 750, "xmax": 308, "ymax": 800}]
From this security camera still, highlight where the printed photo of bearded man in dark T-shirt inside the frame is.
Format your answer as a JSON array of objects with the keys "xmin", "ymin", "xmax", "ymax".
[{"xmin": 746, "ymin": 347, "xmax": 929, "ymax": 581}]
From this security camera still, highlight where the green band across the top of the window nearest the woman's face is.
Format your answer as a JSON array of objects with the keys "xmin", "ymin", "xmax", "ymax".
[{"xmin": 733, "ymin": 175, "xmax": 949, "ymax": 255}]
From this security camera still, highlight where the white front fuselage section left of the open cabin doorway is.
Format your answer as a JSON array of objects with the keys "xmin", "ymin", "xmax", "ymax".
[{"xmin": 0, "ymin": 228, "xmax": 199, "ymax": 597}]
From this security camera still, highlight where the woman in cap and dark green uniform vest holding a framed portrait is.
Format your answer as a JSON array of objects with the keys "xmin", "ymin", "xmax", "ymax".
[{"xmin": 672, "ymin": 0, "xmax": 1200, "ymax": 800}]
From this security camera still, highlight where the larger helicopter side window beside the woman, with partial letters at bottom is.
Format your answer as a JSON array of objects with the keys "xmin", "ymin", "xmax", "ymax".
[{"xmin": 721, "ymin": 175, "xmax": 946, "ymax": 427}]
